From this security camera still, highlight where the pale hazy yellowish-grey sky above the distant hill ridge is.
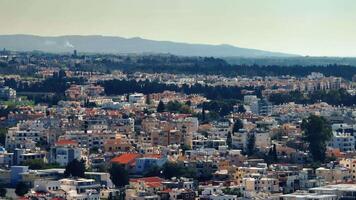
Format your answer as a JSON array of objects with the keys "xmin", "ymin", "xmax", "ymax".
[{"xmin": 0, "ymin": 0, "xmax": 356, "ymax": 56}]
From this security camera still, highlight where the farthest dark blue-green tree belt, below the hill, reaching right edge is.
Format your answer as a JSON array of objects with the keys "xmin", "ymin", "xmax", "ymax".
[{"xmin": 95, "ymin": 55, "xmax": 356, "ymax": 80}]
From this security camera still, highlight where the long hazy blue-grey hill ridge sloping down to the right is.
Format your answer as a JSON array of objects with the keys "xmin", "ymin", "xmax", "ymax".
[{"xmin": 0, "ymin": 35, "xmax": 296, "ymax": 57}]
